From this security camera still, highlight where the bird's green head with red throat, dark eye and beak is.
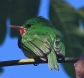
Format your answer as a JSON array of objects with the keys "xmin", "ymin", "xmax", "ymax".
[{"xmin": 10, "ymin": 17, "xmax": 51, "ymax": 35}]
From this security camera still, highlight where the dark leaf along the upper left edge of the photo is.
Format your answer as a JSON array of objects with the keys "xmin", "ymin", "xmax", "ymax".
[{"xmin": 0, "ymin": 0, "xmax": 9, "ymax": 45}]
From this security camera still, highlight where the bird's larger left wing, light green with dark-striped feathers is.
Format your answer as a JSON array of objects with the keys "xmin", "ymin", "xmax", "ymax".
[{"xmin": 22, "ymin": 34, "xmax": 51, "ymax": 57}]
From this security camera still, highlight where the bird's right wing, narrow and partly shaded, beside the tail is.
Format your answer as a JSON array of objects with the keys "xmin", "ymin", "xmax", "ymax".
[{"xmin": 54, "ymin": 36, "xmax": 65, "ymax": 58}]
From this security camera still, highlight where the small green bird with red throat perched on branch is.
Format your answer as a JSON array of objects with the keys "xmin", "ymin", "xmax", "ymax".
[{"xmin": 11, "ymin": 16, "xmax": 65, "ymax": 70}]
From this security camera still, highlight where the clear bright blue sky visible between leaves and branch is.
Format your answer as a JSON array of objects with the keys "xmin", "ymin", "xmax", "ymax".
[{"xmin": 0, "ymin": 0, "xmax": 84, "ymax": 78}]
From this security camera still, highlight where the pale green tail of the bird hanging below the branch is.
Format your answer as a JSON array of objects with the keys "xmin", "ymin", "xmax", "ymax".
[{"xmin": 47, "ymin": 50, "xmax": 59, "ymax": 70}]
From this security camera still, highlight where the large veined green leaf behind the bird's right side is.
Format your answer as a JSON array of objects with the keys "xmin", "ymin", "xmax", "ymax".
[{"xmin": 50, "ymin": 0, "xmax": 84, "ymax": 78}]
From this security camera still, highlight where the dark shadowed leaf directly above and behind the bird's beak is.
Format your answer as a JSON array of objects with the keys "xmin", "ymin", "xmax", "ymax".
[{"xmin": 10, "ymin": 0, "xmax": 40, "ymax": 37}]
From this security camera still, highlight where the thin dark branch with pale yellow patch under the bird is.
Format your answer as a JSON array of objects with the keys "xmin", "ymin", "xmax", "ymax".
[{"xmin": 0, "ymin": 57, "xmax": 78, "ymax": 67}]
